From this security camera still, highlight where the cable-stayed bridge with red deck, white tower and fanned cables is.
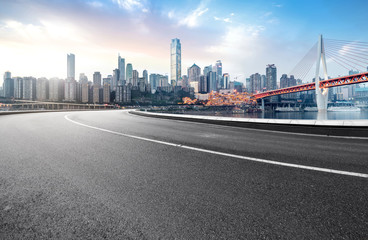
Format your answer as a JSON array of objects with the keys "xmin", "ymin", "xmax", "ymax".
[{"xmin": 252, "ymin": 35, "xmax": 368, "ymax": 112}]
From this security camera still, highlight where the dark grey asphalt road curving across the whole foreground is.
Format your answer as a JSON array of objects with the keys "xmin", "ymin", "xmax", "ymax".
[{"xmin": 0, "ymin": 111, "xmax": 368, "ymax": 239}]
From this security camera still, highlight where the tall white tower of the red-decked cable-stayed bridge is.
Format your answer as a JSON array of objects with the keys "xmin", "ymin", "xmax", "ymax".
[{"xmin": 315, "ymin": 35, "xmax": 328, "ymax": 112}]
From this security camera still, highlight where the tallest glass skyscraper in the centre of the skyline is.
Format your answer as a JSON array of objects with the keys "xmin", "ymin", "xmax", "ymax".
[{"xmin": 170, "ymin": 38, "xmax": 181, "ymax": 86}]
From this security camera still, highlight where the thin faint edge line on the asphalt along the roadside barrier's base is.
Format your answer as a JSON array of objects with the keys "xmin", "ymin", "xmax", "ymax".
[{"xmin": 128, "ymin": 112, "xmax": 368, "ymax": 140}]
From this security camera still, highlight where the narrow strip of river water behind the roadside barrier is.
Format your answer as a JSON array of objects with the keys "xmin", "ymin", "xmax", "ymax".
[{"xmin": 184, "ymin": 111, "xmax": 368, "ymax": 120}]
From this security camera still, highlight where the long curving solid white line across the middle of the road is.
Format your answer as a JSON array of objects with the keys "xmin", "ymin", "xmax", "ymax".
[{"xmin": 64, "ymin": 115, "xmax": 368, "ymax": 178}]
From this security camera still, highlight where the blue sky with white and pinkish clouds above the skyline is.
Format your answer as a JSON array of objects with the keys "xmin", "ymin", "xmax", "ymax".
[{"xmin": 0, "ymin": 0, "xmax": 368, "ymax": 85}]
